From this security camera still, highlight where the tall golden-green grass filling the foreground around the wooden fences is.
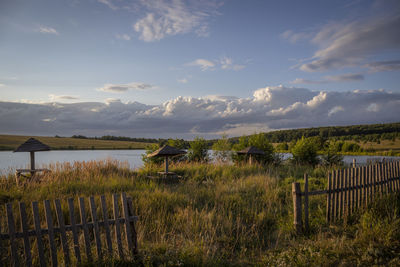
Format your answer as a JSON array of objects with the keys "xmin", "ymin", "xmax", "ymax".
[{"xmin": 0, "ymin": 161, "xmax": 400, "ymax": 266}]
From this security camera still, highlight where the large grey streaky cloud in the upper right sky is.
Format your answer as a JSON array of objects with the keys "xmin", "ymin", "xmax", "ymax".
[{"xmin": 296, "ymin": 12, "xmax": 400, "ymax": 72}]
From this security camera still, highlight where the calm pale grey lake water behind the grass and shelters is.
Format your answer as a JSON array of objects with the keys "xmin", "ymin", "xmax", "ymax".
[{"xmin": 0, "ymin": 150, "xmax": 400, "ymax": 174}]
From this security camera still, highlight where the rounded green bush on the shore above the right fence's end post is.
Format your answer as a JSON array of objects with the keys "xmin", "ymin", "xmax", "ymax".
[{"xmin": 291, "ymin": 136, "xmax": 319, "ymax": 165}]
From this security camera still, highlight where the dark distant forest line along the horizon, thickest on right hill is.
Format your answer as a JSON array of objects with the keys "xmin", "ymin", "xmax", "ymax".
[{"xmin": 67, "ymin": 122, "xmax": 400, "ymax": 147}]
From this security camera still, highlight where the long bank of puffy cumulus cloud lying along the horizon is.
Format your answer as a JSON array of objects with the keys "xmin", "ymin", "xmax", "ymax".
[{"xmin": 0, "ymin": 86, "xmax": 400, "ymax": 138}]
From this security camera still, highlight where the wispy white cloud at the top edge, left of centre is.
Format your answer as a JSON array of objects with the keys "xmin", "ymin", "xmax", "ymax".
[{"xmin": 133, "ymin": 0, "xmax": 220, "ymax": 42}]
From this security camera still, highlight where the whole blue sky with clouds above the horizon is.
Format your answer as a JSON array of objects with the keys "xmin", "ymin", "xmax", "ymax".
[{"xmin": 0, "ymin": 0, "xmax": 400, "ymax": 139}]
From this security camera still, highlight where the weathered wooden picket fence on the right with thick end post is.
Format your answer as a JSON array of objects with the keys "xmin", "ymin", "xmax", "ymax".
[{"xmin": 292, "ymin": 161, "xmax": 400, "ymax": 232}]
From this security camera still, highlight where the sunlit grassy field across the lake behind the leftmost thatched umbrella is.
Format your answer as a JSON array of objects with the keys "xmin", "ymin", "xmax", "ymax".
[{"xmin": 0, "ymin": 135, "xmax": 152, "ymax": 150}]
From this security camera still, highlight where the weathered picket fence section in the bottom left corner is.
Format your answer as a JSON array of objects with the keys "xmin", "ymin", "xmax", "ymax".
[{"xmin": 0, "ymin": 193, "xmax": 138, "ymax": 266}]
